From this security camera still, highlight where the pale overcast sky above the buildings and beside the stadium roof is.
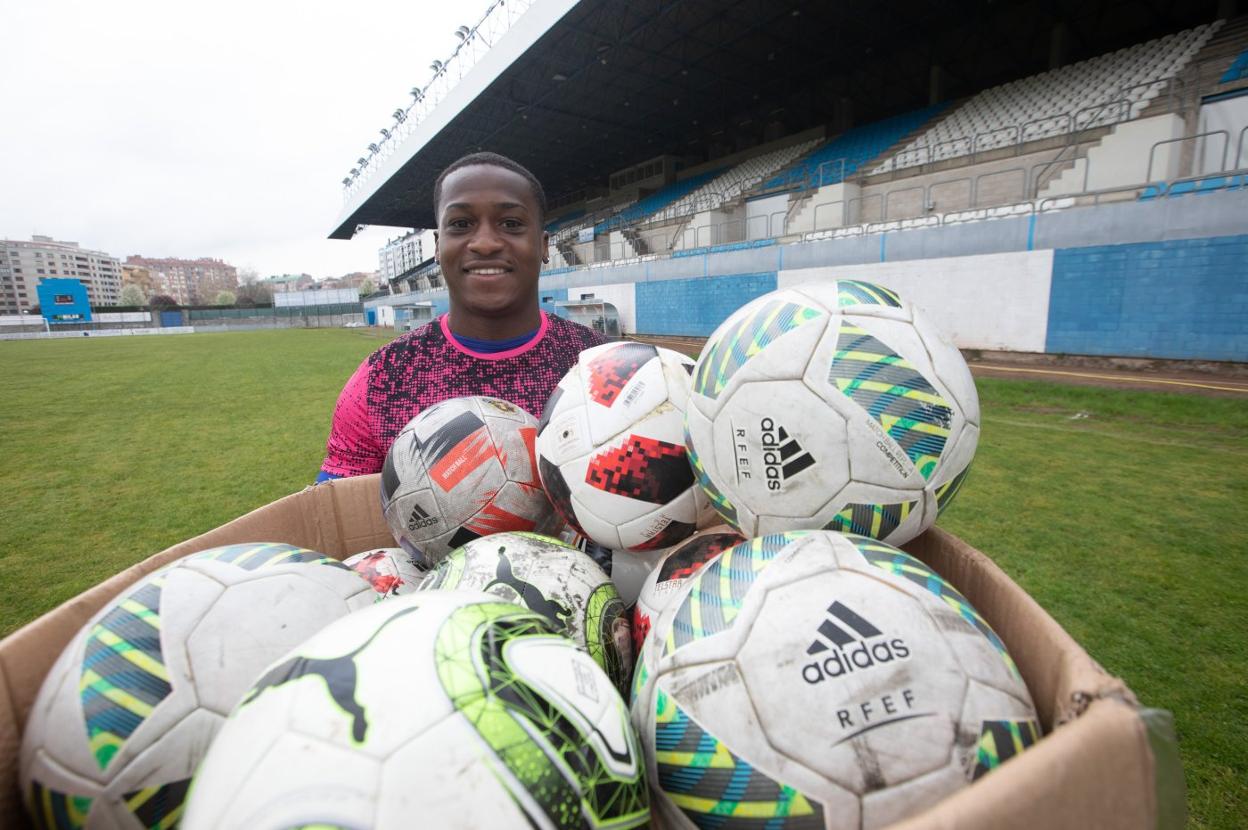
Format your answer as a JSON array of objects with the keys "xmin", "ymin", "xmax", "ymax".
[{"xmin": 0, "ymin": 0, "xmax": 489, "ymax": 277}]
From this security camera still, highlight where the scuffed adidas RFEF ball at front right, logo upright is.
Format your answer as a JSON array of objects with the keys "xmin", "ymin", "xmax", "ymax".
[{"xmin": 633, "ymin": 530, "xmax": 1040, "ymax": 830}]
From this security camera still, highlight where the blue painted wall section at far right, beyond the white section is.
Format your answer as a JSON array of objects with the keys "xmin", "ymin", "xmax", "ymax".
[{"xmin": 1045, "ymin": 236, "xmax": 1248, "ymax": 361}]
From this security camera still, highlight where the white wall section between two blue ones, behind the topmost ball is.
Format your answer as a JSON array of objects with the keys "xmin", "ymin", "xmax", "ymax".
[{"xmin": 776, "ymin": 245, "xmax": 1053, "ymax": 352}]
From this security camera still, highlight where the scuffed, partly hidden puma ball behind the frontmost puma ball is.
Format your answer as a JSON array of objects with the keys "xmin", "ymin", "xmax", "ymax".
[{"xmin": 421, "ymin": 533, "xmax": 633, "ymax": 689}]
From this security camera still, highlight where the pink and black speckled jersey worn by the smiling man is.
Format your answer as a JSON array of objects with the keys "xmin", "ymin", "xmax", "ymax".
[{"xmin": 321, "ymin": 312, "xmax": 604, "ymax": 476}]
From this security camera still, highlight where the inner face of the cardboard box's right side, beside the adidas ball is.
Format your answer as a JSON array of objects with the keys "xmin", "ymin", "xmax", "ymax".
[{"xmin": 902, "ymin": 528, "xmax": 1134, "ymax": 730}]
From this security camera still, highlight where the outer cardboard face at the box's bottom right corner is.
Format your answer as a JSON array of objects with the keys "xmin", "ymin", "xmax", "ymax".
[{"xmin": 890, "ymin": 700, "xmax": 1157, "ymax": 830}]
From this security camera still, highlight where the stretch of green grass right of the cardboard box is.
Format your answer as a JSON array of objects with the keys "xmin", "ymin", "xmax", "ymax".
[{"xmin": 941, "ymin": 379, "xmax": 1248, "ymax": 828}]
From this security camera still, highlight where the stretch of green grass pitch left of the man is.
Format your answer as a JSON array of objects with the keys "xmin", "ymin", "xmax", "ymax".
[{"xmin": 0, "ymin": 330, "xmax": 394, "ymax": 635}]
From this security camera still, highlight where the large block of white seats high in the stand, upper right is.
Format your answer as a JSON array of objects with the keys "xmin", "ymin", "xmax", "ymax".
[{"xmin": 872, "ymin": 21, "xmax": 1221, "ymax": 173}]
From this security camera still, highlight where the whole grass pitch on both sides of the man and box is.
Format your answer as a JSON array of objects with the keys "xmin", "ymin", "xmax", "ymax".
[{"xmin": 0, "ymin": 330, "xmax": 1248, "ymax": 829}]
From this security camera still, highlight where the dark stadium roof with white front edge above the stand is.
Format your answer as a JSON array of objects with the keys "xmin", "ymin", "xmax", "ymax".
[{"xmin": 331, "ymin": 0, "xmax": 1218, "ymax": 238}]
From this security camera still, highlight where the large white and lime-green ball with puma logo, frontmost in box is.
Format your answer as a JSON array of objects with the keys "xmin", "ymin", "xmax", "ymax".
[{"xmin": 182, "ymin": 590, "xmax": 650, "ymax": 830}]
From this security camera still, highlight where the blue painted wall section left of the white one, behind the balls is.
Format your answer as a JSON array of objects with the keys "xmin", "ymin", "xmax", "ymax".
[{"xmin": 636, "ymin": 271, "xmax": 776, "ymax": 336}]
